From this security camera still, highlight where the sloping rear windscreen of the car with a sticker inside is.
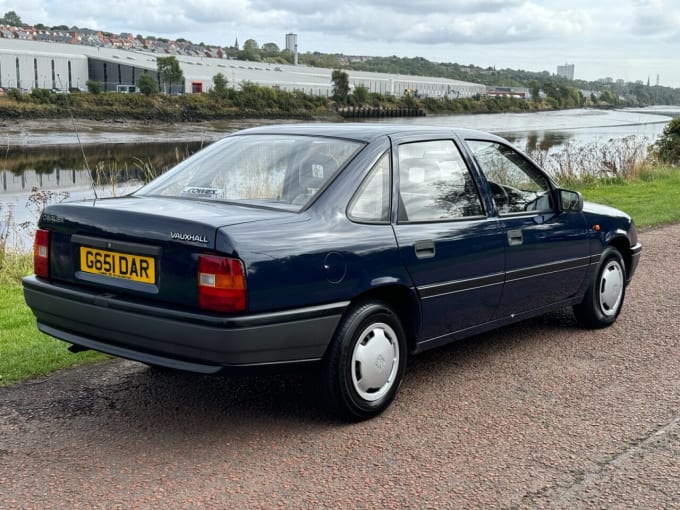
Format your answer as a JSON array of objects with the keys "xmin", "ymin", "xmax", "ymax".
[{"xmin": 136, "ymin": 134, "xmax": 364, "ymax": 211}]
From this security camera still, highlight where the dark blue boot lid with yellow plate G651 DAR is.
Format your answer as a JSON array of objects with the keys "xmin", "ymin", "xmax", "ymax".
[{"xmin": 39, "ymin": 197, "xmax": 296, "ymax": 307}]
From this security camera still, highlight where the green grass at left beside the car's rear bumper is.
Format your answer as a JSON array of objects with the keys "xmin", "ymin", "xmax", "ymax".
[{"xmin": 0, "ymin": 254, "xmax": 106, "ymax": 386}]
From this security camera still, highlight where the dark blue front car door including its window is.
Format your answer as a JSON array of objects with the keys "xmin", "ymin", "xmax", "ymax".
[{"xmin": 465, "ymin": 140, "xmax": 590, "ymax": 318}]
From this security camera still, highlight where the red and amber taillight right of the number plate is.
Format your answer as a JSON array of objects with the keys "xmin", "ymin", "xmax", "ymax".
[{"xmin": 198, "ymin": 255, "xmax": 247, "ymax": 313}]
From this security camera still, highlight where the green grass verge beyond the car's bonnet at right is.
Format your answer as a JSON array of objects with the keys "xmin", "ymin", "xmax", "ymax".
[{"xmin": 573, "ymin": 168, "xmax": 680, "ymax": 228}]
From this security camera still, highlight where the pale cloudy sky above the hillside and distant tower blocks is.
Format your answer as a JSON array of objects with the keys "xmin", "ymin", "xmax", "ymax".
[{"xmin": 5, "ymin": 0, "xmax": 680, "ymax": 88}]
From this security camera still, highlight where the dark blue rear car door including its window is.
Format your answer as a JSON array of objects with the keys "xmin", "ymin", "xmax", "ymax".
[{"xmin": 393, "ymin": 139, "xmax": 504, "ymax": 345}]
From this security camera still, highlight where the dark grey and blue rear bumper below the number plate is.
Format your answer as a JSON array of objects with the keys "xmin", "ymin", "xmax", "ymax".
[{"xmin": 23, "ymin": 276, "xmax": 349, "ymax": 373}]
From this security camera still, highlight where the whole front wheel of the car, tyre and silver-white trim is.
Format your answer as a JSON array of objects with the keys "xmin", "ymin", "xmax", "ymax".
[{"xmin": 574, "ymin": 246, "xmax": 626, "ymax": 329}]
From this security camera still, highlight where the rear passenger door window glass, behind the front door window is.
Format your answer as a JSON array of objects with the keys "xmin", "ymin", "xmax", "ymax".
[{"xmin": 397, "ymin": 140, "xmax": 484, "ymax": 222}]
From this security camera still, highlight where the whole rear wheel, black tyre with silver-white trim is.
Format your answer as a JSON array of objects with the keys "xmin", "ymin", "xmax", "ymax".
[{"xmin": 321, "ymin": 301, "xmax": 406, "ymax": 421}]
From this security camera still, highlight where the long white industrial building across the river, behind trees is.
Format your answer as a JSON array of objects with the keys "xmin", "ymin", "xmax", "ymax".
[{"xmin": 0, "ymin": 38, "xmax": 485, "ymax": 98}]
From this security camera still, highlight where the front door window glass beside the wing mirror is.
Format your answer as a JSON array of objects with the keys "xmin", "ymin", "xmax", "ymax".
[{"xmin": 466, "ymin": 140, "xmax": 552, "ymax": 215}]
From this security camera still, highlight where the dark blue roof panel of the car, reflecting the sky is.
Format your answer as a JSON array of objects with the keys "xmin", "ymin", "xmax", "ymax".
[{"xmin": 234, "ymin": 122, "xmax": 502, "ymax": 142}]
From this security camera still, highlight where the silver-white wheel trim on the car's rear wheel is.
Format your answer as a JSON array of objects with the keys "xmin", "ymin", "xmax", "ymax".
[{"xmin": 350, "ymin": 323, "xmax": 399, "ymax": 402}]
